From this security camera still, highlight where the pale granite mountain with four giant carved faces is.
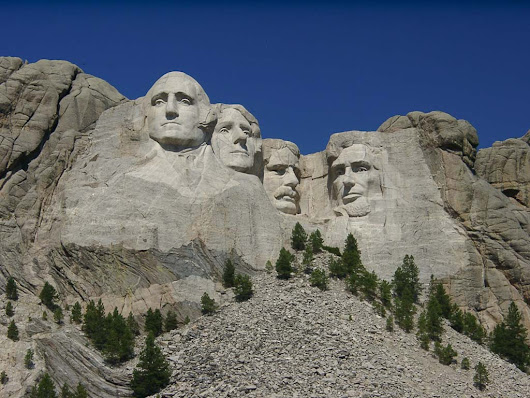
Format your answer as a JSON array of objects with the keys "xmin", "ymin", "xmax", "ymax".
[{"xmin": 0, "ymin": 57, "xmax": 530, "ymax": 396}]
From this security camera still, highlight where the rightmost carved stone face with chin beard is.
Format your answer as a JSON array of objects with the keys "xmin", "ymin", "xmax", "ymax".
[{"xmin": 331, "ymin": 144, "xmax": 380, "ymax": 217}]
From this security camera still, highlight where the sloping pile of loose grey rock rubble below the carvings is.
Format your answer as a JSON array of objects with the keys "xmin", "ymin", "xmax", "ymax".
[{"xmin": 155, "ymin": 273, "xmax": 530, "ymax": 398}]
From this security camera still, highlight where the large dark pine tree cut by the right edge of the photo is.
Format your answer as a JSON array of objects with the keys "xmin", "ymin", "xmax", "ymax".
[{"xmin": 490, "ymin": 302, "xmax": 530, "ymax": 372}]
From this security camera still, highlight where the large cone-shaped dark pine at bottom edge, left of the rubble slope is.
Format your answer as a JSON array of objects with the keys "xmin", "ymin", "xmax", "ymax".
[{"xmin": 131, "ymin": 333, "xmax": 171, "ymax": 398}]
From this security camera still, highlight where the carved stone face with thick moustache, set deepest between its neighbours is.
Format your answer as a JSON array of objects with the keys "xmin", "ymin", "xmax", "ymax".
[{"xmin": 263, "ymin": 147, "xmax": 300, "ymax": 214}]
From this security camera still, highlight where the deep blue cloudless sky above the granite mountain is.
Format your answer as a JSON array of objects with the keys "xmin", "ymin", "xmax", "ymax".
[{"xmin": 0, "ymin": 2, "xmax": 530, "ymax": 154}]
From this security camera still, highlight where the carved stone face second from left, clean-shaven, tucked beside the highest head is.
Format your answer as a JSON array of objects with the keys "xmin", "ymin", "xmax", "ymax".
[{"xmin": 212, "ymin": 108, "xmax": 261, "ymax": 173}]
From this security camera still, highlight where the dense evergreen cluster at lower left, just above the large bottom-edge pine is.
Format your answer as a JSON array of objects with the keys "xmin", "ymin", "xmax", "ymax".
[{"xmin": 82, "ymin": 299, "xmax": 134, "ymax": 364}]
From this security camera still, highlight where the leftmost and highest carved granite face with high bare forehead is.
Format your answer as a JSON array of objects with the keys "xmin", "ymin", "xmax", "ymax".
[{"xmin": 146, "ymin": 72, "xmax": 208, "ymax": 149}]
